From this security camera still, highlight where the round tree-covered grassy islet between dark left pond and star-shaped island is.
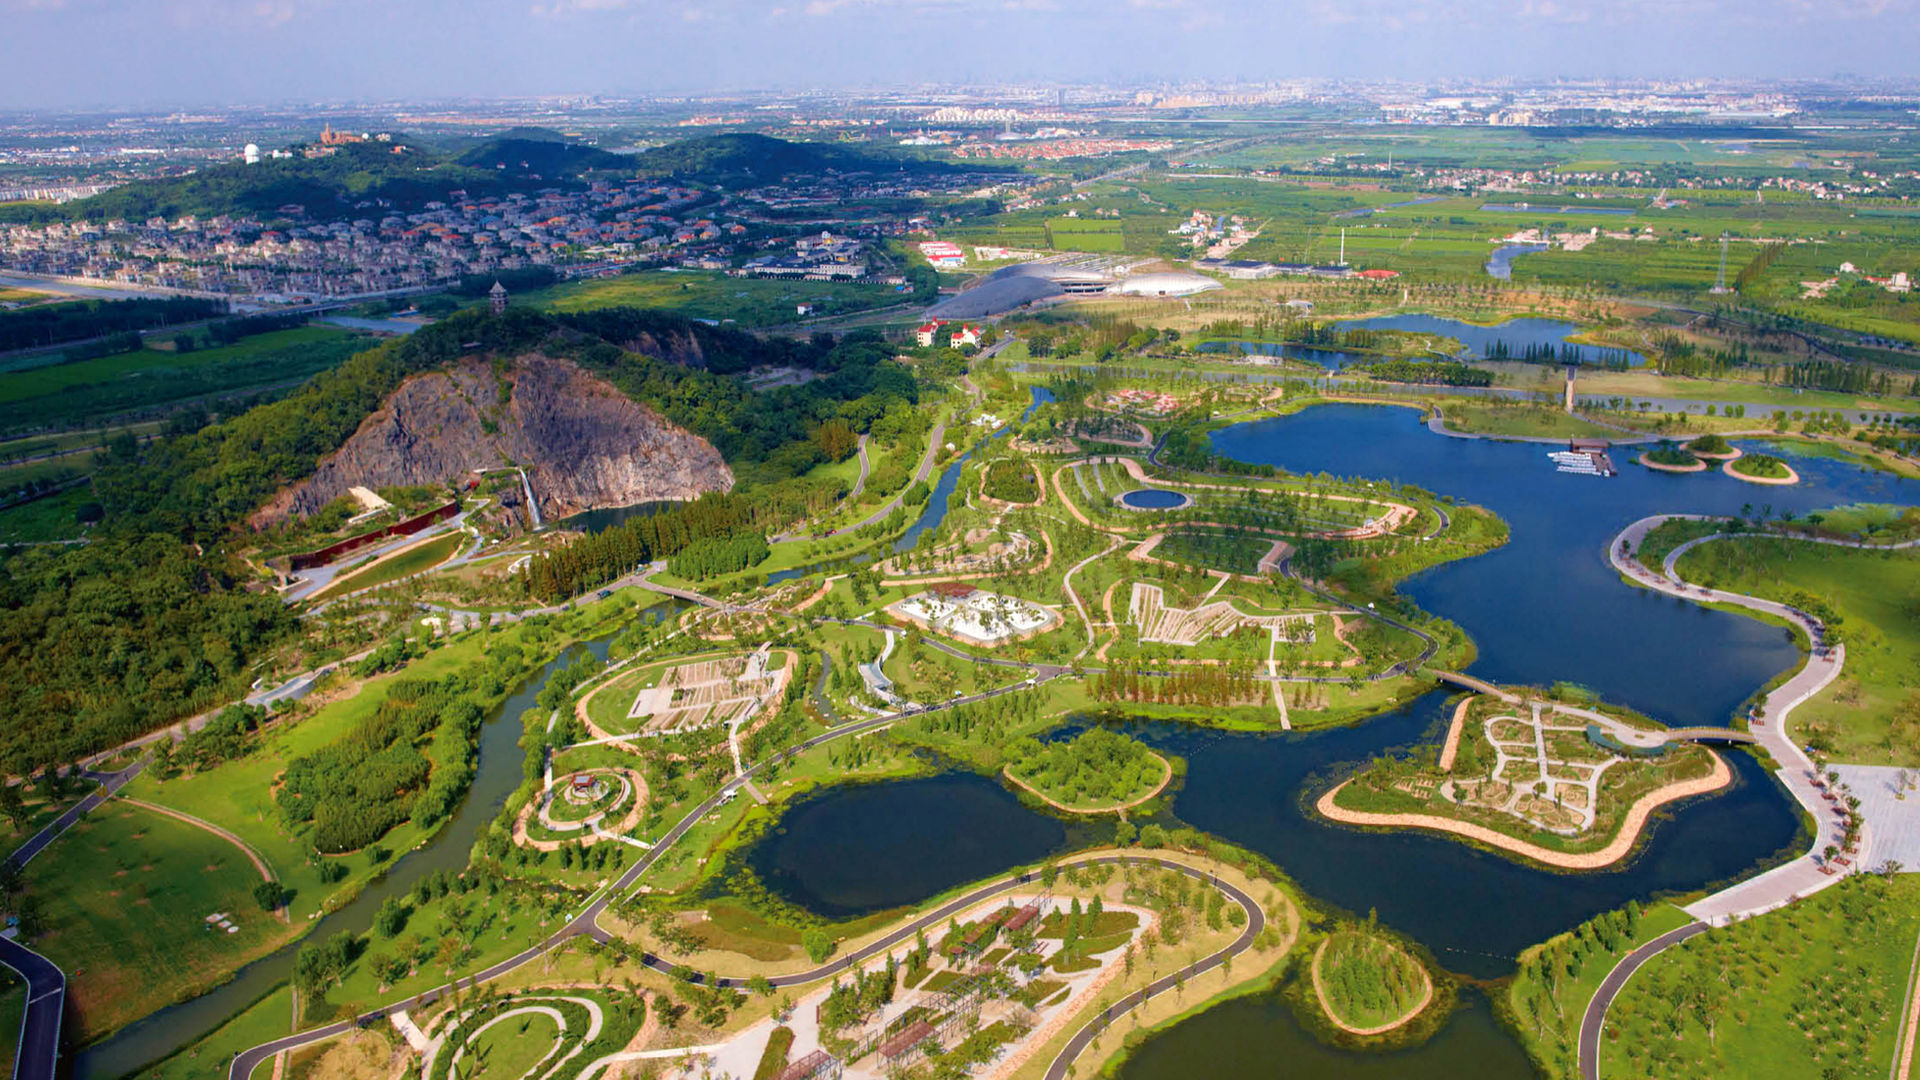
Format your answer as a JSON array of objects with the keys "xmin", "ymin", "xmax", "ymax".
[{"xmin": 1006, "ymin": 728, "xmax": 1173, "ymax": 813}]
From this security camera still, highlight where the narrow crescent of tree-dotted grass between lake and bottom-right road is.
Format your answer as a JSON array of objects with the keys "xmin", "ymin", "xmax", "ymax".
[{"xmin": 1500, "ymin": 903, "xmax": 1692, "ymax": 1080}]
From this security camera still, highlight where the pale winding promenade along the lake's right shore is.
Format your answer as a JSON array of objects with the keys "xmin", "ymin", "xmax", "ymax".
[{"xmin": 1578, "ymin": 513, "xmax": 1920, "ymax": 1080}]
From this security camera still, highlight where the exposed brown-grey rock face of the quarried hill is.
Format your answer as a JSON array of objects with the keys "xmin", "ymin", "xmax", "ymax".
[{"xmin": 252, "ymin": 356, "xmax": 733, "ymax": 528}]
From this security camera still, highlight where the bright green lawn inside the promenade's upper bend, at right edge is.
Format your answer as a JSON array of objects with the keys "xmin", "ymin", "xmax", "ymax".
[{"xmin": 1678, "ymin": 536, "xmax": 1920, "ymax": 765}]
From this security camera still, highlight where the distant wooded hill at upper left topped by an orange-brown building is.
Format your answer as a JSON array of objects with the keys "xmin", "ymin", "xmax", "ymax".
[{"xmin": 0, "ymin": 142, "xmax": 626, "ymax": 223}]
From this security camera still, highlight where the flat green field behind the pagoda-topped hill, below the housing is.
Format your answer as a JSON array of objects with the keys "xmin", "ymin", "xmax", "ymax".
[{"xmin": 516, "ymin": 271, "xmax": 910, "ymax": 327}]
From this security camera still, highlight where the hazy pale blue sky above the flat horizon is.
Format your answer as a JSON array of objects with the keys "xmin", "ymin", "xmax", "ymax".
[{"xmin": 0, "ymin": 0, "xmax": 1920, "ymax": 111}]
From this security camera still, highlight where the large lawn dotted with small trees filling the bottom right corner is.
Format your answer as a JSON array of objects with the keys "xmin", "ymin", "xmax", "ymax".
[{"xmin": 1599, "ymin": 876, "xmax": 1920, "ymax": 1080}]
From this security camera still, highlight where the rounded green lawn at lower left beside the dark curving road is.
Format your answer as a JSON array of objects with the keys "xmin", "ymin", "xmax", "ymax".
[{"xmin": 27, "ymin": 801, "xmax": 294, "ymax": 1040}]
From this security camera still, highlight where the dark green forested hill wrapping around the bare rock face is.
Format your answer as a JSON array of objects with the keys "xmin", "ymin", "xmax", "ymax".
[{"xmin": 0, "ymin": 309, "xmax": 918, "ymax": 774}]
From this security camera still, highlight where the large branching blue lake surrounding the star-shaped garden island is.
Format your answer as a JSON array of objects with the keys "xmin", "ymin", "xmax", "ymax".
[{"xmin": 751, "ymin": 405, "xmax": 1920, "ymax": 1080}]
